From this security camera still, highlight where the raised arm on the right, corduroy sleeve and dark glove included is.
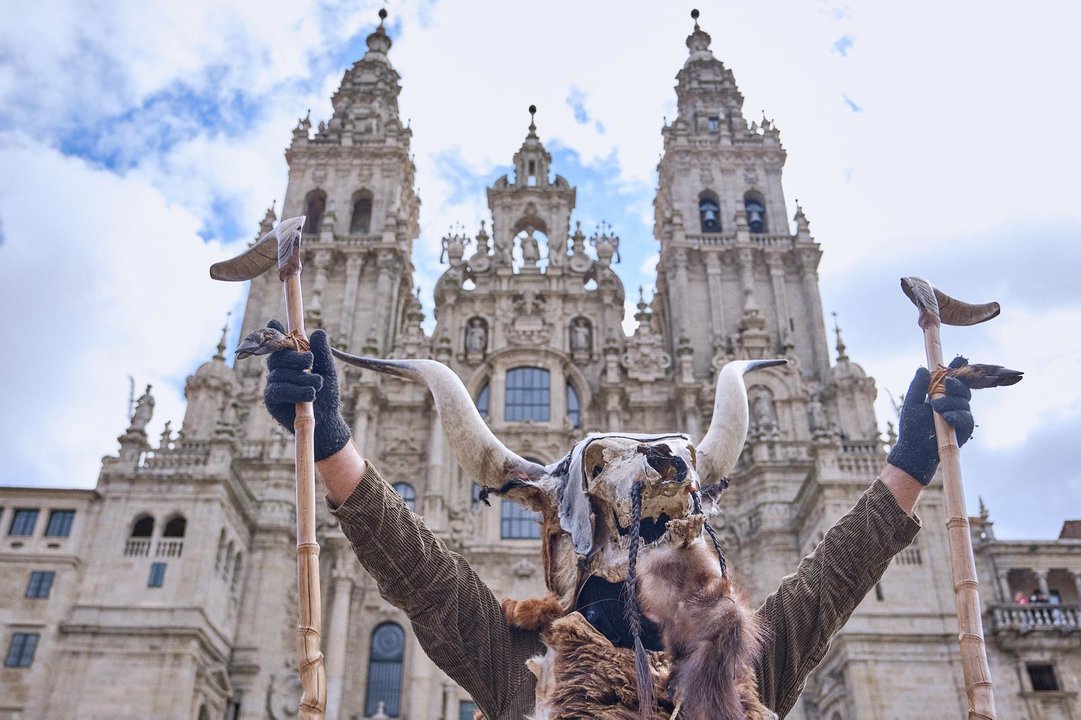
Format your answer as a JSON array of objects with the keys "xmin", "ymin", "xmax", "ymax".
[{"xmin": 758, "ymin": 368, "xmax": 973, "ymax": 717}]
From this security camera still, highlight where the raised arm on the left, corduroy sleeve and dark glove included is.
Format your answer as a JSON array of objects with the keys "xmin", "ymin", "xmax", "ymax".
[{"xmin": 265, "ymin": 322, "xmax": 539, "ymax": 717}]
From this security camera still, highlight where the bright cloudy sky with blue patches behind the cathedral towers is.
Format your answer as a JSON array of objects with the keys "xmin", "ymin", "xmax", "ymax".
[{"xmin": 0, "ymin": 0, "xmax": 1081, "ymax": 538}]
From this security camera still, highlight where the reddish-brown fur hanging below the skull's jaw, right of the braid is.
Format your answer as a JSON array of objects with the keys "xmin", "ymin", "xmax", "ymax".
[{"xmin": 638, "ymin": 542, "xmax": 773, "ymax": 720}]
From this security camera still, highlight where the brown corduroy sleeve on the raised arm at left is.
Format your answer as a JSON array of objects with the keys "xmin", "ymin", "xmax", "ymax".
[{"xmin": 322, "ymin": 463, "xmax": 541, "ymax": 718}]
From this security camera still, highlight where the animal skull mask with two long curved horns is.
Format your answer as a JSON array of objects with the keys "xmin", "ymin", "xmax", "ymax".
[{"xmin": 333, "ymin": 350, "xmax": 785, "ymax": 611}]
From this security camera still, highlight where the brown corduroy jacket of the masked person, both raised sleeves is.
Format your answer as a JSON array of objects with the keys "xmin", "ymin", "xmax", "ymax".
[{"xmin": 331, "ymin": 463, "xmax": 920, "ymax": 720}]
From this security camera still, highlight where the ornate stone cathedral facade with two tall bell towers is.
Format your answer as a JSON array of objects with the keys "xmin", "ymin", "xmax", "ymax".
[{"xmin": 0, "ymin": 11, "xmax": 1081, "ymax": 720}]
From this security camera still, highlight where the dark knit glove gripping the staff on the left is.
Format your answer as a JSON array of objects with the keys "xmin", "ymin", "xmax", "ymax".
[{"xmin": 263, "ymin": 320, "xmax": 352, "ymax": 462}]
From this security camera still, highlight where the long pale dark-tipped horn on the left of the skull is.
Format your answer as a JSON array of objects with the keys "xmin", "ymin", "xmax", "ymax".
[{"xmin": 331, "ymin": 348, "xmax": 544, "ymax": 488}]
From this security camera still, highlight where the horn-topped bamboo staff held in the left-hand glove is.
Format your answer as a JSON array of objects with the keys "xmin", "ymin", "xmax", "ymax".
[{"xmin": 210, "ymin": 215, "xmax": 326, "ymax": 720}]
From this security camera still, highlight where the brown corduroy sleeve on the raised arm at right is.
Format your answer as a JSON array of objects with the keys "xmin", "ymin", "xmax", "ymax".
[{"xmin": 757, "ymin": 473, "xmax": 920, "ymax": 718}]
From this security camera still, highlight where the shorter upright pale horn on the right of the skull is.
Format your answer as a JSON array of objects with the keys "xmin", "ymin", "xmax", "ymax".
[{"xmin": 698, "ymin": 360, "xmax": 788, "ymax": 485}]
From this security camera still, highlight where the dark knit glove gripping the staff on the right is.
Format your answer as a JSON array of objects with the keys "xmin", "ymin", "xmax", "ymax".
[{"xmin": 886, "ymin": 360, "xmax": 975, "ymax": 485}]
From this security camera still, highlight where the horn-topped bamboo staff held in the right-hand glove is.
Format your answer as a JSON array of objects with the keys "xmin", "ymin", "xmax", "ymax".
[{"xmin": 900, "ymin": 278, "xmax": 1000, "ymax": 720}]
